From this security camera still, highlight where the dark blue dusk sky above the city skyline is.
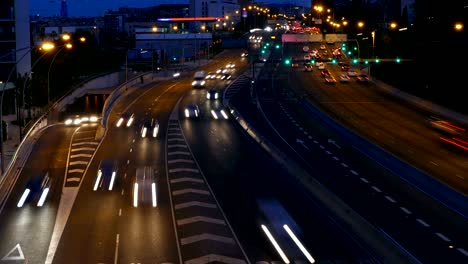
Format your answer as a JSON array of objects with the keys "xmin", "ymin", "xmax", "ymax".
[{"xmin": 30, "ymin": 0, "xmax": 310, "ymax": 17}]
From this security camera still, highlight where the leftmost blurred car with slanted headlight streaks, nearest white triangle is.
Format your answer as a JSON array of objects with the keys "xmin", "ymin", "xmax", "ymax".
[{"xmin": 16, "ymin": 170, "xmax": 52, "ymax": 208}]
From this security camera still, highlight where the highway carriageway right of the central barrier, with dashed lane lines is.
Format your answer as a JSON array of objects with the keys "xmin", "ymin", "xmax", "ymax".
[{"xmin": 245, "ymin": 40, "xmax": 468, "ymax": 263}]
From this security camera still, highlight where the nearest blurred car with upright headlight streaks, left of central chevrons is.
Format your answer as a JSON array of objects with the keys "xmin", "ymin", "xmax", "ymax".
[{"xmin": 133, "ymin": 166, "xmax": 158, "ymax": 208}]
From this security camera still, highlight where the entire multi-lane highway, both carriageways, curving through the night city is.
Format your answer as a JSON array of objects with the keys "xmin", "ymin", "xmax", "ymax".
[{"xmin": 0, "ymin": 33, "xmax": 468, "ymax": 264}]
